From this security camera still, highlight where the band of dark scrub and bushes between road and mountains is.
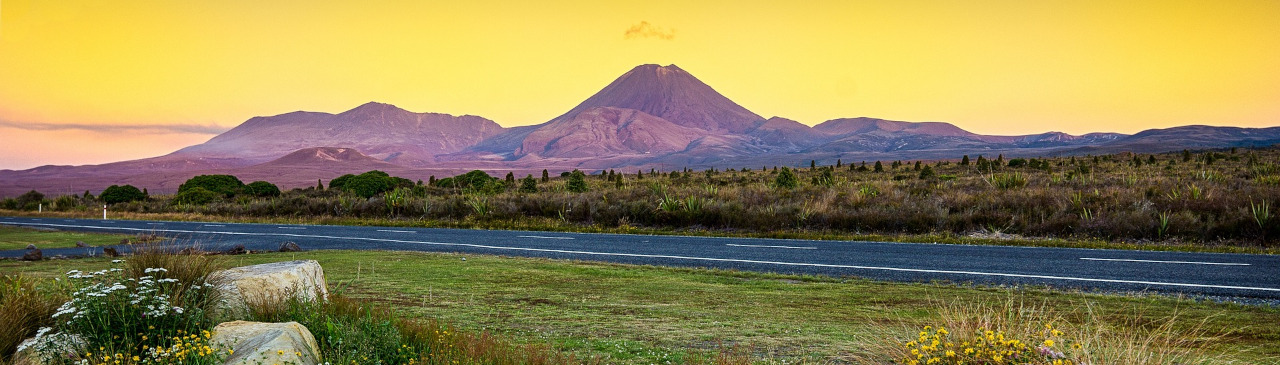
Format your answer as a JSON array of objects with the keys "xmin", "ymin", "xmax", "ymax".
[{"xmin": 10, "ymin": 147, "xmax": 1280, "ymax": 252}]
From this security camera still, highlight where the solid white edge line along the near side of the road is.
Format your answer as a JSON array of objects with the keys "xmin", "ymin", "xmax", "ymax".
[{"xmin": 3, "ymin": 219, "xmax": 1280, "ymax": 292}]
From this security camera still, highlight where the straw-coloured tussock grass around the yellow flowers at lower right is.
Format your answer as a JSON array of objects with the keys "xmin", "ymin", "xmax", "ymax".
[{"xmin": 846, "ymin": 297, "xmax": 1280, "ymax": 365}]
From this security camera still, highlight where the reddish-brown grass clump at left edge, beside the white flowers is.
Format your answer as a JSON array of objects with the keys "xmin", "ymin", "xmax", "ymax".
[{"xmin": 0, "ymin": 274, "xmax": 61, "ymax": 364}]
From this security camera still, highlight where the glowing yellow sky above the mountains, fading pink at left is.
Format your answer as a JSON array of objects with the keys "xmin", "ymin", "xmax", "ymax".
[{"xmin": 0, "ymin": 0, "xmax": 1280, "ymax": 168}]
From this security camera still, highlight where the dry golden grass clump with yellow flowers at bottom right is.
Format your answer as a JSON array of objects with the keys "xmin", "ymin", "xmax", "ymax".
[{"xmin": 855, "ymin": 300, "xmax": 1254, "ymax": 365}]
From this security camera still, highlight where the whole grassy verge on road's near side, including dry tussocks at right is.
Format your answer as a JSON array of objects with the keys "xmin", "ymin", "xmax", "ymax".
[{"xmin": 0, "ymin": 225, "xmax": 1280, "ymax": 364}]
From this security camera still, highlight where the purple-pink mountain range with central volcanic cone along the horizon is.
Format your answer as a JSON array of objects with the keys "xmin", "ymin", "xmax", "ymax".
[{"xmin": 0, "ymin": 64, "xmax": 1280, "ymax": 196}]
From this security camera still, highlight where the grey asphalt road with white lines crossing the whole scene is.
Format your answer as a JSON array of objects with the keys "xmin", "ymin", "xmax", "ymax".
[{"xmin": 0, "ymin": 216, "xmax": 1280, "ymax": 297}]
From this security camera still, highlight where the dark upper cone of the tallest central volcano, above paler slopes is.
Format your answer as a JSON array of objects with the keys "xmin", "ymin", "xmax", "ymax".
[{"xmin": 557, "ymin": 64, "xmax": 764, "ymax": 133}]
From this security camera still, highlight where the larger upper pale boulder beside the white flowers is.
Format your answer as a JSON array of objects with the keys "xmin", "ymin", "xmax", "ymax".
[{"xmin": 210, "ymin": 260, "xmax": 329, "ymax": 316}]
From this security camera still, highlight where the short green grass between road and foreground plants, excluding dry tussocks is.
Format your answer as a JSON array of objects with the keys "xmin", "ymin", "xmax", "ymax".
[{"xmin": 0, "ymin": 225, "xmax": 1280, "ymax": 364}]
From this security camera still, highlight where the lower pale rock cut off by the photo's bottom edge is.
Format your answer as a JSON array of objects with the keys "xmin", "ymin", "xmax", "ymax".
[{"xmin": 209, "ymin": 320, "xmax": 320, "ymax": 365}]
